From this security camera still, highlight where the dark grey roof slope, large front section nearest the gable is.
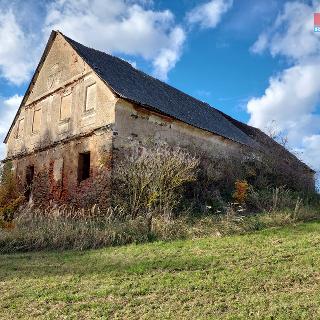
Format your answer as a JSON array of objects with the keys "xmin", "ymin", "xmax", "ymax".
[{"xmin": 64, "ymin": 36, "xmax": 256, "ymax": 147}]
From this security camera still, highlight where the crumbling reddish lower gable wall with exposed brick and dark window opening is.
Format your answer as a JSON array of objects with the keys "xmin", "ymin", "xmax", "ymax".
[{"xmin": 13, "ymin": 128, "xmax": 113, "ymax": 207}]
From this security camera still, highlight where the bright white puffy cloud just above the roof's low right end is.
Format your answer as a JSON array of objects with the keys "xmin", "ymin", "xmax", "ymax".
[{"xmin": 247, "ymin": 64, "xmax": 320, "ymax": 130}]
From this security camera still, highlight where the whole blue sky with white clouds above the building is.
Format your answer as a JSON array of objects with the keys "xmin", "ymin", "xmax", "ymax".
[{"xmin": 0, "ymin": 0, "xmax": 320, "ymax": 182}]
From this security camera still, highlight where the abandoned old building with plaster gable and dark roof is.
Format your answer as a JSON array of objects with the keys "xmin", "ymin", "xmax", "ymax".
[{"xmin": 4, "ymin": 31, "xmax": 314, "ymax": 208}]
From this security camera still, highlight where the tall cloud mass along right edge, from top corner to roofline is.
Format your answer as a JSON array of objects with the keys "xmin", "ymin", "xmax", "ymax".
[{"xmin": 247, "ymin": 2, "xmax": 320, "ymax": 174}]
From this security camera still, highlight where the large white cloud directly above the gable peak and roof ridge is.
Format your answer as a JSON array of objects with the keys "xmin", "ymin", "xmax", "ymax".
[{"xmin": 45, "ymin": 0, "xmax": 185, "ymax": 79}]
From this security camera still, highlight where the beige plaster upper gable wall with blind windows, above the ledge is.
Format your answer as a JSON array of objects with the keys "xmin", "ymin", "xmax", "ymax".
[{"xmin": 7, "ymin": 34, "xmax": 116, "ymax": 158}]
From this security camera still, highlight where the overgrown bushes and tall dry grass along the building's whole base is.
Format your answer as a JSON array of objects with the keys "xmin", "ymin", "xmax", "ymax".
[{"xmin": 0, "ymin": 145, "xmax": 320, "ymax": 252}]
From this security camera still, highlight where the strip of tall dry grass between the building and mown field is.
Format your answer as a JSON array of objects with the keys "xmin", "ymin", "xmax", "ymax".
[{"xmin": 0, "ymin": 201, "xmax": 320, "ymax": 253}]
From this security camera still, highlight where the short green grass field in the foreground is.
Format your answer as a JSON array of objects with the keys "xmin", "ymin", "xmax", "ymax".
[{"xmin": 0, "ymin": 223, "xmax": 320, "ymax": 319}]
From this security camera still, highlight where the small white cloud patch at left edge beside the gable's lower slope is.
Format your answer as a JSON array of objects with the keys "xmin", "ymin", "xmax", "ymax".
[{"xmin": 0, "ymin": 94, "xmax": 22, "ymax": 159}]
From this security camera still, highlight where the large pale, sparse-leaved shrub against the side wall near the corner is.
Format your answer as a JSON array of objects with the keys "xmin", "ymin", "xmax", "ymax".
[{"xmin": 113, "ymin": 145, "xmax": 199, "ymax": 218}]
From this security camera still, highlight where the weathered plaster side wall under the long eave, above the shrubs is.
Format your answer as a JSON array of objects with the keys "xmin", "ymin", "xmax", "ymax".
[{"xmin": 114, "ymin": 100, "xmax": 251, "ymax": 158}]
